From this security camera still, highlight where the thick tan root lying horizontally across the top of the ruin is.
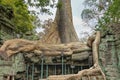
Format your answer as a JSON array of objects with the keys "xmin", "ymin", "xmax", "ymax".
[{"xmin": 0, "ymin": 39, "xmax": 91, "ymax": 59}]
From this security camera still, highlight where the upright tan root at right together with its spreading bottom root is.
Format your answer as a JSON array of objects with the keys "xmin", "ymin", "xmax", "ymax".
[{"xmin": 48, "ymin": 31, "xmax": 106, "ymax": 80}]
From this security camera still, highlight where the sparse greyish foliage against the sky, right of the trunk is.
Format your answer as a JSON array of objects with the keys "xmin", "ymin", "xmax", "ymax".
[{"xmin": 81, "ymin": 0, "xmax": 107, "ymax": 24}]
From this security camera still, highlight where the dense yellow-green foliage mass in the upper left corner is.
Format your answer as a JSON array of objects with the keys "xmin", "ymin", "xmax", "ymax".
[{"xmin": 0, "ymin": 0, "xmax": 34, "ymax": 33}]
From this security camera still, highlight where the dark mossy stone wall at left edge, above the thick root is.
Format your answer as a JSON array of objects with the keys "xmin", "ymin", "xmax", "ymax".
[{"xmin": 0, "ymin": 5, "xmax": 15, "ymax": 41}]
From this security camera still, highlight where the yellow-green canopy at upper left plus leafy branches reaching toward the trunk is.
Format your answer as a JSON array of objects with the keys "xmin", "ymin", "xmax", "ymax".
[{"xmin": 0, "ymin": 0, "xmax": 55, "ymax": 33}]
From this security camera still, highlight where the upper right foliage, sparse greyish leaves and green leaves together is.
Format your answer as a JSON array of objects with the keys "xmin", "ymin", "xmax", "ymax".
[{"xmin": 81, "ymin": 0, "xmax": 120, "ymax": 31}]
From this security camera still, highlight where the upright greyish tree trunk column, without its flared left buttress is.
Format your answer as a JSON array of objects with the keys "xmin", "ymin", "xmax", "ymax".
[{"xmin": 58, "ymin": 0, "xmax": 78, "ymax": 43}]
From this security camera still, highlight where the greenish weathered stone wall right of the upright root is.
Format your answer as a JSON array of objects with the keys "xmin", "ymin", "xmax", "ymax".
[{"xmin": 99, "ymin": 23, "xmax": 120, "ymax": 80}]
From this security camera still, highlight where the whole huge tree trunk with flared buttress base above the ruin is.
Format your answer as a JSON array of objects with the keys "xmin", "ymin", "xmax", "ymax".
[{"xmin": 41, "ymin": 0, "xmax": 79, "ymax": 44}]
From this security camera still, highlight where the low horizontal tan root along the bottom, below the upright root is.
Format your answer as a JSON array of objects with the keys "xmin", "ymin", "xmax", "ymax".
[{"xmin": 47, "ymin": 68, "xmax": 106, "ymax": 80}]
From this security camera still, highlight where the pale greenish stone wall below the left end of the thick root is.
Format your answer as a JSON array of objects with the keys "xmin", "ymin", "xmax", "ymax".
[{"xmin": 0, "ymin": 53, "xmax": 25, "ymax": 80}]
